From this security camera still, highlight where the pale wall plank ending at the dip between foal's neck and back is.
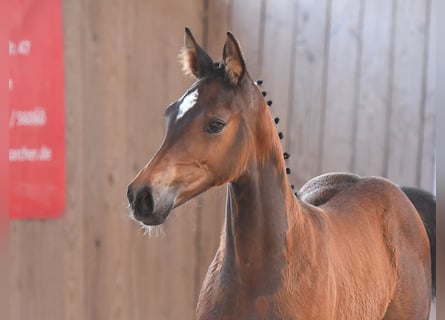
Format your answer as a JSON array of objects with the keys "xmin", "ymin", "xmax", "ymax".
[{"xmin": 287, "ymin": 0, "xmax": 331, "ymax": 186}]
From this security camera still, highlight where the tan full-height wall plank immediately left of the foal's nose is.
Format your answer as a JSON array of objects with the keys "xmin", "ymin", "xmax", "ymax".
[{"xmin": 93, "ymin": 0, "xmax": 133, "ymax": 320}]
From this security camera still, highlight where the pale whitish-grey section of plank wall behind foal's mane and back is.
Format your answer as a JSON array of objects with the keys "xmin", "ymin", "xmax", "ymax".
[{"xmin": 210, "ymin": 0, "xmax": 436, "ymax": 190}]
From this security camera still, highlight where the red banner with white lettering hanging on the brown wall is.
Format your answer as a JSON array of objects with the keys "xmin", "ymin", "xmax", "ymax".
[{"xmin": 8, "ymin": 0, "xmax": 65, "ymax": 218}]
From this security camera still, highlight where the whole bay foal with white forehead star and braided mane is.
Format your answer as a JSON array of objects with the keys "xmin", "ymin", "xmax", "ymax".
[{"xmin": 128, "ymin": 29, "xmax": 432, "ymax": 320}]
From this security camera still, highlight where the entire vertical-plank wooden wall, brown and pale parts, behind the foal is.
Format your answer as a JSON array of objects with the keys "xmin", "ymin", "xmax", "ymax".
[{"xmin": 10, "ymin": 0, "xmax": 437, "ymax": 320}]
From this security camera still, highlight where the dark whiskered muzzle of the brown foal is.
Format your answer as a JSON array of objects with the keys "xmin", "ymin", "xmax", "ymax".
[{"xmin": 127, "ymin": 184, "xmax": 176, "ymax": 226}]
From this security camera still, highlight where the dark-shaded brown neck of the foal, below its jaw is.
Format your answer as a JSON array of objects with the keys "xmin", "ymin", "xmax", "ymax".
[{"xmin": 223, "ymin": 108, "xmax": 298, "ymax": 292}]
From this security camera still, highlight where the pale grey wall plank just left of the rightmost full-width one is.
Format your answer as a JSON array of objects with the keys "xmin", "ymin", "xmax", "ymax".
[{"xmin": 352, "ymin": 0, "xmax": 392, "ymax": 176}]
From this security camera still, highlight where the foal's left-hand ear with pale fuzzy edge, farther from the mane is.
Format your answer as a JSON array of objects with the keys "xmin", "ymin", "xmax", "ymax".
[{"xmin": 179, "ymin": 27, "xmax": 213, "ymax": 79}]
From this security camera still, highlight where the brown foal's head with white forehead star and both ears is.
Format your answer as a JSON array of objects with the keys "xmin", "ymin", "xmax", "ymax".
[{"xmin": 127, "ymin": 28, "xmax": 279, "ymax": 225}]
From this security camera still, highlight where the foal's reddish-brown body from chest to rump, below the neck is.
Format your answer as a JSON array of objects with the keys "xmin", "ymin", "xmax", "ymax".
[{"xmin": 197, "ymin": 174, "xmax": 431, "ymax": 319}]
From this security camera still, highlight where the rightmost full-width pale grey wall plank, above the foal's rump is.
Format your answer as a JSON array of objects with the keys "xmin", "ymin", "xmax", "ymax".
[{"xmin": 387, "ymin": 0, "xmax": 426, "ymax": 185}]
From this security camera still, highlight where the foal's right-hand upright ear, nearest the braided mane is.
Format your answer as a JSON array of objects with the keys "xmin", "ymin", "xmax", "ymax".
[{"xmin": 223, "ymin": 32, "xmax": 246, "ymax": 86}]
